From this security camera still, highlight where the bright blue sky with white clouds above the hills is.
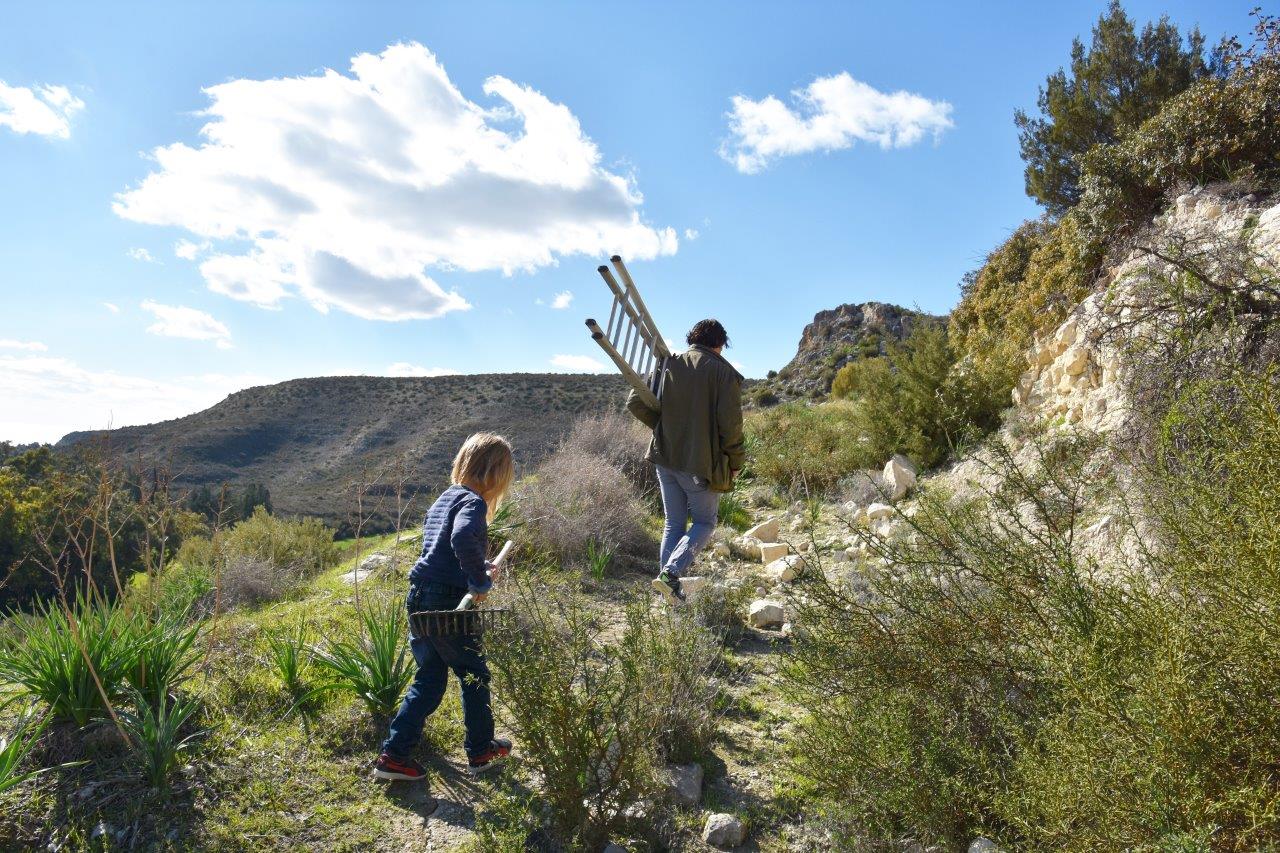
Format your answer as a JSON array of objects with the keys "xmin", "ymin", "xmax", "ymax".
[{"xmin": 0, "ymin": 0, "xmax": 1253, "ymax": 441}]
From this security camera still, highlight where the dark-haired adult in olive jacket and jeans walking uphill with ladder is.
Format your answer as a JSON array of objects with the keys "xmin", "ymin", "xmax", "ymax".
[{"xmin": 627, "ymin": 319, "xmax": 745, "ymax": 603}]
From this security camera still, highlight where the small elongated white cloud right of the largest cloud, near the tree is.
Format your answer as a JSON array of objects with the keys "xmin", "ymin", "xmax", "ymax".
[{"xmin": 721, "ymin": 72, "xmax": 952, "ymax": 174}]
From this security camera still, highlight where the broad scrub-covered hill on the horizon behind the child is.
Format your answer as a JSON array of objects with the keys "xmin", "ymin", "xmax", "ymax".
[{"xmin": 58, "ymin": 374, "xmax": 625, "ymax": 525}]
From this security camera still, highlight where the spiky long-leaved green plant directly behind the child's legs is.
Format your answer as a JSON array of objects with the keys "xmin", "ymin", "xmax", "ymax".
[{"xmin": 308, "ymin": 598, "xmax": 415, "ymax": 720}]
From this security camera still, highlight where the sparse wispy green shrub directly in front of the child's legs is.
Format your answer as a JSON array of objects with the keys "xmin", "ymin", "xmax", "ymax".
[{"xmin": 485, "ymin": 585, "xmax": 714, "ymax": 850}]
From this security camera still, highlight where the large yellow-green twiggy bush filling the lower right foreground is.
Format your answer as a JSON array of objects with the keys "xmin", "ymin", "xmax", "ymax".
[{"xmin": 787, "ymin": 374, "xmax": 1280, "ymax": 850}]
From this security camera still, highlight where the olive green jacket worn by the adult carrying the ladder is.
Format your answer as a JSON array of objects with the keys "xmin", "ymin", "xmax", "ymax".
[{"xmin": 627, "ymin": 346, "xmax": 746, "ymax": 492}]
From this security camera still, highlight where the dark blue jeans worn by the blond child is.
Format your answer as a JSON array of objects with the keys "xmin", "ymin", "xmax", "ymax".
[{"xmin": 383, "ymin": 583, "xmax": 493, "ymax": 760}]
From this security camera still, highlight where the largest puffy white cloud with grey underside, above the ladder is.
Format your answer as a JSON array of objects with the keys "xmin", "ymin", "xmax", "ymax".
[{"xmin": 114, "ymin": 44, "xmax": 678, "ymax": 320}]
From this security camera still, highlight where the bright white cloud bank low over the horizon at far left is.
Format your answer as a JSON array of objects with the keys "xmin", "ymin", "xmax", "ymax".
[{"xmin": 0, "ymin": 355, "xmax": 269, "ymax": 442}]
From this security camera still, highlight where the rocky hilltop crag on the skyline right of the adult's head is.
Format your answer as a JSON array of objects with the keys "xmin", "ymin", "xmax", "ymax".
[{"xmin": 753, "ymin": 302, "xmax": 942, "ymax": 405}]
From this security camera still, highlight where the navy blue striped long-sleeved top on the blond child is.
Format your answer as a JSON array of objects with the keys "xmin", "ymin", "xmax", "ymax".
[{"xmin": 408, "ymin": 485, "xmax": 493, "ymax": 593}]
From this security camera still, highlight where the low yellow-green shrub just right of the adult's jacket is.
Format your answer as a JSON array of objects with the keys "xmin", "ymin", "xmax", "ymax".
[{"xmin": 746, "ymin": 403, "xmax": 865, "ymax": 494}]
